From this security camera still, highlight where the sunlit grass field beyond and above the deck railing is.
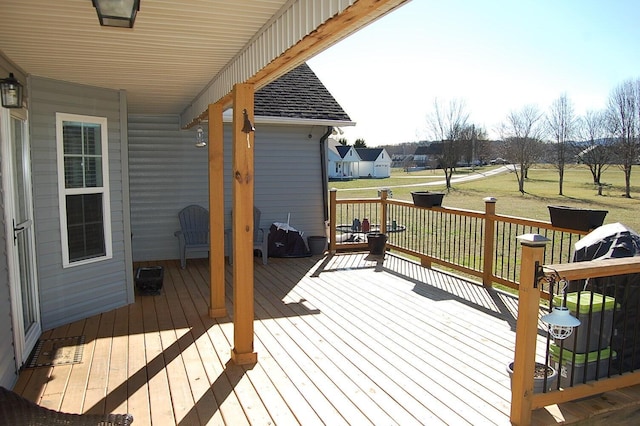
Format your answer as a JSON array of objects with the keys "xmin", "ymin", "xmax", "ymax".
[{"xmin": 329, "ymin": 165, "xmax": 640, "ymax": 232}]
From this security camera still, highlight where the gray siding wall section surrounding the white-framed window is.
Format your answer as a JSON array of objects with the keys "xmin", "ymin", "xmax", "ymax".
[{"xmin": 29, "ymin": 77, "xmax": 133, "ymax": 330}]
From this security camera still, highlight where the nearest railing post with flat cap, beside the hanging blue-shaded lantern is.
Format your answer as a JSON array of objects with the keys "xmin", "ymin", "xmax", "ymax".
[{"xmin": 511, "ymin": 234, "xmax": 549, "ymax": 426}]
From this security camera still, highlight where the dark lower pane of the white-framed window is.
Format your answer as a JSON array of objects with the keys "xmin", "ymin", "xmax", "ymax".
[{"xmin": 66, "ymin": 194, "xmax": 106, "ymax": 262}]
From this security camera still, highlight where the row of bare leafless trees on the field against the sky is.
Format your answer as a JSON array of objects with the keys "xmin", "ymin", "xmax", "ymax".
[{"xmin": 427, "ymin": 78, "xmax": 640, "ymax": 198}]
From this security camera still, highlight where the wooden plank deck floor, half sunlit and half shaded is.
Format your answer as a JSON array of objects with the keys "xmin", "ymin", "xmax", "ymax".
[{"xmin": 14, "ymin": 254, "xmax": 638, "ymax": 426}]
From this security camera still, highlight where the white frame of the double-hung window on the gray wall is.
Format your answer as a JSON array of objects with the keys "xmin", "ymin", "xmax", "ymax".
[{"xmin": 56, "ymin": 112, "xmax": 113, "ymax": 268}]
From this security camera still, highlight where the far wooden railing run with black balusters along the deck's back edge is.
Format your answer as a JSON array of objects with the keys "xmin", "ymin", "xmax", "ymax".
[{"xmin": 329, "ymin": 189, "xmax": 586, "ymax": 289}]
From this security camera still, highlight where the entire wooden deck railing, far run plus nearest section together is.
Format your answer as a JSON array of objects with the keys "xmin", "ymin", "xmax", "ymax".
[{"xmin": 329, "ymin": 190, "xmax": 640, "ymax": 425}]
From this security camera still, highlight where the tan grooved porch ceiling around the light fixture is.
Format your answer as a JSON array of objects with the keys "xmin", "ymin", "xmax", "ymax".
[{"xmin": 0, "ymin": 0, "xmax": 404, "ymax": 125}]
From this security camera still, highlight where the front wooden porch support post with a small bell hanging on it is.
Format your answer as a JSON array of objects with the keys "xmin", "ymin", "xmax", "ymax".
[{"xmin": 231, "ymin": 84, "xmax": 258, "ymax": 365}]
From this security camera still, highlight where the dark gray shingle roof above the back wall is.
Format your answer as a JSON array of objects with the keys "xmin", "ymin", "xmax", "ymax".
[{"xmin": 254, "ymin": 64, "xmax": 351, "ymax": 121}]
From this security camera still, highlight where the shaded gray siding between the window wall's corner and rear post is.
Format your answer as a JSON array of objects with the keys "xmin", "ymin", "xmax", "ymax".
[{"xmin": 129, "ymin": 115, "xmax": 209, "ymax": 261}]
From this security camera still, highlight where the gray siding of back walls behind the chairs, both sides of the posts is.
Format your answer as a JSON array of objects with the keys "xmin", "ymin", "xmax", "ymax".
[{"xmin": 129, "ymin": 115, "xmax": 326, "ymax": 261}]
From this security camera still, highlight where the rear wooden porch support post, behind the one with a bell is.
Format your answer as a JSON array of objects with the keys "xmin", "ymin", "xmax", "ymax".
[{"xmin": 207, "ymin": 104, "xmax": 227, "ymax": 318}]
